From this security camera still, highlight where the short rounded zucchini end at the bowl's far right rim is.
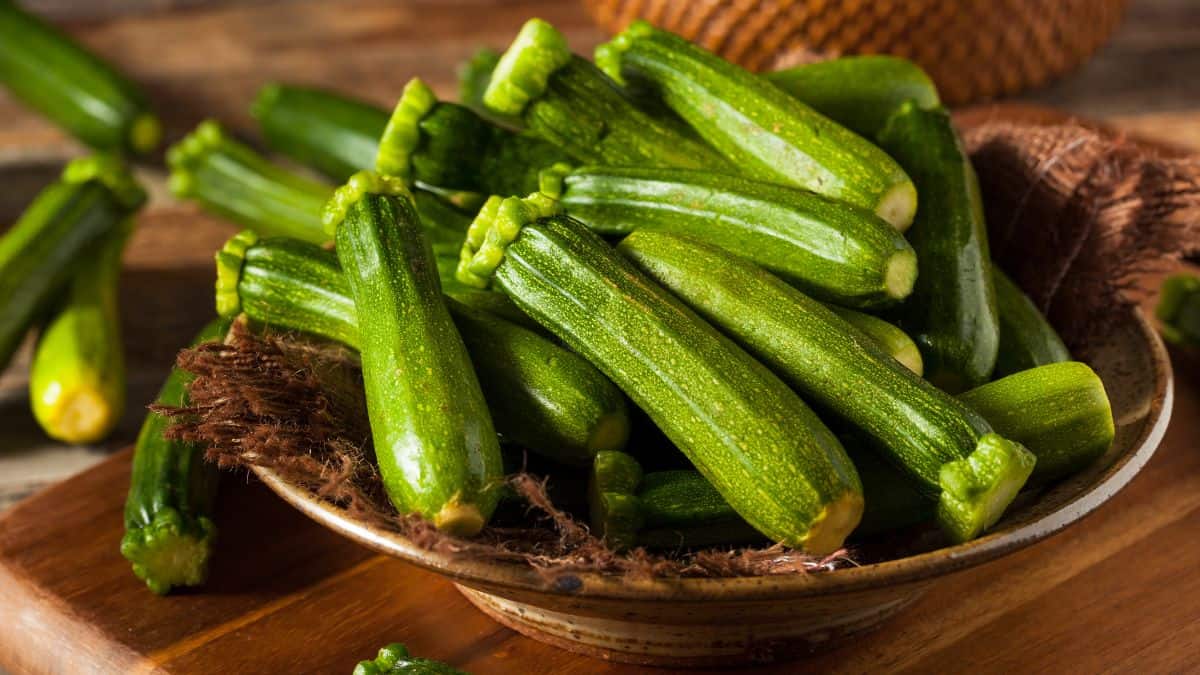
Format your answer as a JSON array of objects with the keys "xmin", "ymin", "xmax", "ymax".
[{"xmin": 959, "ymin": 362, "xmax": 1116, "ymax": 484}]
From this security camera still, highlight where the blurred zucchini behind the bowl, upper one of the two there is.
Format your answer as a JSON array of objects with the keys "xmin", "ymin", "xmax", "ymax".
[{"xmin": 250, "ymin": 83, "xmax": 388, "ymax": 180}]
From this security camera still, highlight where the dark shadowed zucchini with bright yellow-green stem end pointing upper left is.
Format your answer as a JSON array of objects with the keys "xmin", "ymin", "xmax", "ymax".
[{"xmin": 376, "ymin": 78, "xmax": 569, "ymax": 196}]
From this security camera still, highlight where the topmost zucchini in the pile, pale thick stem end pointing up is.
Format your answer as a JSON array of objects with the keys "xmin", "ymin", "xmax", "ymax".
[{"xmin": 484, "ymin": 19, "xmax": 732, "ymax": 171}]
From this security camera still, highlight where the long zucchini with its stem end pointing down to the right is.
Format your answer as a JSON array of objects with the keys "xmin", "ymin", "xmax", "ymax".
[{"xmin": 614, "ymin": 232, "xmax": 1036, "ymax": 540}]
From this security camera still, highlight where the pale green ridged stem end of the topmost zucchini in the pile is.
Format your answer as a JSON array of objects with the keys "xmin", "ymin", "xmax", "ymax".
[{"xmin": 484, "ymin": 18, "xmax": 572, "ymax": 115}]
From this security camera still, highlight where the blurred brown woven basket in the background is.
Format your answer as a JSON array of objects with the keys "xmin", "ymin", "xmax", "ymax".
[{"xmin": 583, "ymin": 0, "xmax": 1128, "ymax": 104}]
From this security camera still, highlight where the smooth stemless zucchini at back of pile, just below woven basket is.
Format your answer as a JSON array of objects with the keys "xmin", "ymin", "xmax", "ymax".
[{"xmin": 762, "ymin": 54, "xmax": 942, "ymax": 138}]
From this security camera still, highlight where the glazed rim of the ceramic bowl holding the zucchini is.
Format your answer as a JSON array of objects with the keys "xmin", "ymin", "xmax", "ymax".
[{"xmin": 252, "ymin": 307, "xmax": 1175, "ymax": 602}]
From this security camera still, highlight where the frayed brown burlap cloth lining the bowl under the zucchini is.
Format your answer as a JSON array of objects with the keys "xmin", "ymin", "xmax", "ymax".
[{"xmin": 164, "ymin": 115, "xmax": 1200, "ymax": 584}]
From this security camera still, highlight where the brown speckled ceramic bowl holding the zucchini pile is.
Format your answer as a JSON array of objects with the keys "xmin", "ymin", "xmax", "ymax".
[{"xmin": 250, "ymin": 310, "xmax": 1172, "ymax": 667}]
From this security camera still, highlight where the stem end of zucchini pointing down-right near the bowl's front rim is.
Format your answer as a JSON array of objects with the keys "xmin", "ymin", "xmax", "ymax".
[{"xmin": 937, "ymin": 434, "xmax": 1037, "ymax": 542}]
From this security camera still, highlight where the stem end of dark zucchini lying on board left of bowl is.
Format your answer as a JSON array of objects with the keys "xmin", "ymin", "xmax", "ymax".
[{"xmin": 121, "ymin": 508, "xmax": 216, "ymax": 596}]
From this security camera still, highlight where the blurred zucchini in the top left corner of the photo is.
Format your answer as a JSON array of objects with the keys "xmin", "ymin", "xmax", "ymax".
[{"xmin": 0, "ymin": 0, "xmax": 162, "ymax": 155}]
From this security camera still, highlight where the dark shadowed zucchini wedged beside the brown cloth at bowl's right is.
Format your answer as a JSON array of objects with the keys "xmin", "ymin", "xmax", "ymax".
[{"xmin": 991, "ymin": 264, "xmax": 1070, "ymax": 378}]
